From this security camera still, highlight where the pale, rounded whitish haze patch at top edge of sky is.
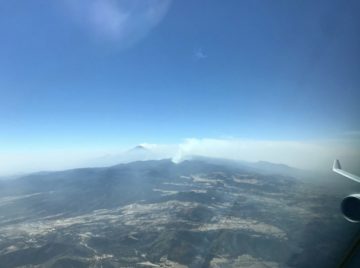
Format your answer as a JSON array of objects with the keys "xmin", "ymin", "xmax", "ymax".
[{"xmin": 66, "ymin": 0, "xmax": 171, "ymax": 46}]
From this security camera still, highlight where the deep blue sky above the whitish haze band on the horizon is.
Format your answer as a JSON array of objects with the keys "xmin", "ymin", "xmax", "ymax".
[{"xmin": 0, "ymin": 0, "xmax": 360, "ymax": 151}]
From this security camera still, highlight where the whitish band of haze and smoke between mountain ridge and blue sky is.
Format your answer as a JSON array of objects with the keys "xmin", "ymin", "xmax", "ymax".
[{"xmin": 0, "ymin": 135, "xmax": 360, "ymax": 176}]
